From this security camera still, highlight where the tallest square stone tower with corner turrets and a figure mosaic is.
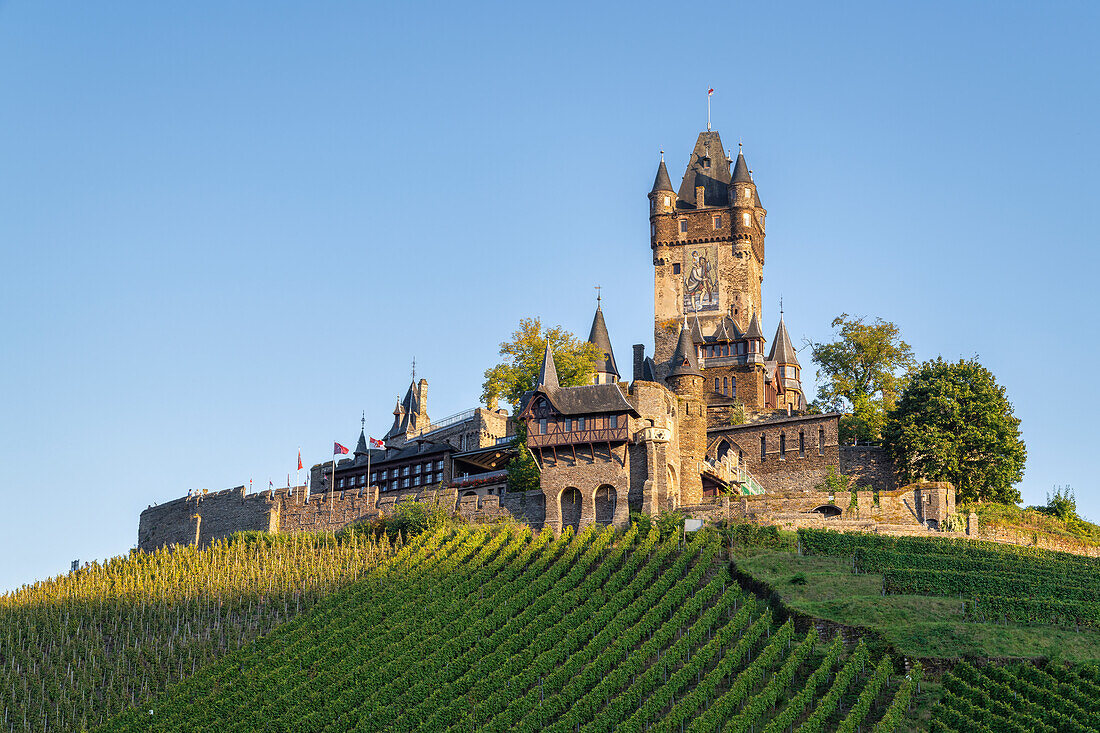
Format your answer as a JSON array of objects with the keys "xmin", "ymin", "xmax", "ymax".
[{"xmin": 649, "ymin": 131, "xmax": 767, "ymax": 363}]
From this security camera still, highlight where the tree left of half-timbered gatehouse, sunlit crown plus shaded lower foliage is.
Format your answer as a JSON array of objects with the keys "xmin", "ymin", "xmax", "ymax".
[{"xmin": 482, "ymin": 318, "xmax": 601, "ymax": 491}]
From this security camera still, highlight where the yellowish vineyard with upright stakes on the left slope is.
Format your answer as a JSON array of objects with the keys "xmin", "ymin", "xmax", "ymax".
[{"xmin": 0, "ymin": 535, "xmax": 392, "ymax": 731}]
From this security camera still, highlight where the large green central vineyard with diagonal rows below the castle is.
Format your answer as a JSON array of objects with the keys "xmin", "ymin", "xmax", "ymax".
[{"xmin": 100, "ymin": 526, "xmax": 919, "ymax": 733}]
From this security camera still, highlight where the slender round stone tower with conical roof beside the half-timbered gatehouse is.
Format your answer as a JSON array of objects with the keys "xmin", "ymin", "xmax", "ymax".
[{"xmin": 664, "ymin": 324, "xmax": 706, "ymax": 508}]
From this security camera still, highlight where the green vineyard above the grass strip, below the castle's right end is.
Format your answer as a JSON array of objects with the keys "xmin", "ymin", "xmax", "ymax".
[{"xmin": 799, "ymin": 529, "xmax": 1100, "ymax": 627}]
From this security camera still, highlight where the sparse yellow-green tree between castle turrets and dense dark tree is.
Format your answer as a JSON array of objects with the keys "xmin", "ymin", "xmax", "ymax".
[{"xmin": 811, "ymin": 314, "xmax": 916, "ymax": 442}]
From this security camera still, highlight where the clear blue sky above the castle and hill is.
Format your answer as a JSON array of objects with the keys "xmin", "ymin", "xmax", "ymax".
[{"xmin": 0, "ymin": 1, "xmax": 1100, "ymax": 589}]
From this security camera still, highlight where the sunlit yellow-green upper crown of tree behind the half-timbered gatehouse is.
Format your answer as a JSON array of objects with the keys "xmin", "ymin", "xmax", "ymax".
[{"xmin": 482, "ymin": 318, "xmax": 601, "ymax": 414}]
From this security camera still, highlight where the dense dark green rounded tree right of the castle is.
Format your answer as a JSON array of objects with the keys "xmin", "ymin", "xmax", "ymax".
[{"xmin": 886, "ymin": 358, "xmax": 1027, "ymax": 504}]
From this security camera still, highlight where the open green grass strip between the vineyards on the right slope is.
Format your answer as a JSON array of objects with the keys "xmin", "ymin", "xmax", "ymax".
[{"xmin": 736, "ymin": 550, "xmax": 1100, "ymax": 661}]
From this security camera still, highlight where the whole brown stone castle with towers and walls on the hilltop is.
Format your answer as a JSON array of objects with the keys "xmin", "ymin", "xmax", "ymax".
[{"xmin": 139, "ymin": 130, "xmax": 955, "ymax": 548}]
